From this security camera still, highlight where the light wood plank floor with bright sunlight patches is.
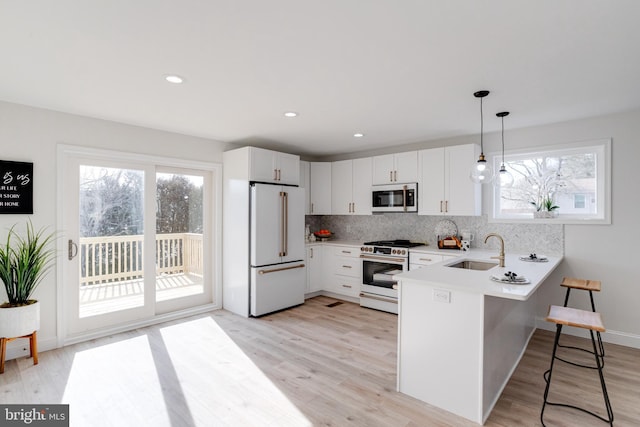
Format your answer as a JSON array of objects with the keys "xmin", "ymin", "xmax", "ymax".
[{"xmin": 0, "ymin": 297, "xmax": 640, "ymax": 427}]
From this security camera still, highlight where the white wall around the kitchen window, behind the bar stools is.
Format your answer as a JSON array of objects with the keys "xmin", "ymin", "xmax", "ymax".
[{"xmin": 498, "ymin": 111, "xmax": 640, "ymax": 348}]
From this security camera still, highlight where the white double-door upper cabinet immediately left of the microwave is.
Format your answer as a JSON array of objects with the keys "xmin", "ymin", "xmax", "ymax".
[{"xmin": 331, "ymin": 157, "xmax": 372, "ymax": 215}]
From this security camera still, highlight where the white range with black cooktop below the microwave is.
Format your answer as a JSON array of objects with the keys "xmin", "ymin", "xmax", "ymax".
[{"xmin": 360, "ymin": 240, "xmax": 424, "ymax": 314}]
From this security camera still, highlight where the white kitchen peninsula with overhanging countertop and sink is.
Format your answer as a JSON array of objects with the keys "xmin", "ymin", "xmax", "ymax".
[{"xmin": 394, "ymin": 250, "xmax": 562, "ymax": 424}]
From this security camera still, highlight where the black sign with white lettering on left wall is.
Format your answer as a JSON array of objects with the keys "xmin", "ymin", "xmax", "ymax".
[{"xmin": 0, "ymin": 160, "xmax": 33, "ymax": 214}]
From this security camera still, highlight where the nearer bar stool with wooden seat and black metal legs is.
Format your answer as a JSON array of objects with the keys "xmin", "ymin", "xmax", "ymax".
[{"xmin": 540, "ymin": 305, "xmax": 613, "ymax": 426}]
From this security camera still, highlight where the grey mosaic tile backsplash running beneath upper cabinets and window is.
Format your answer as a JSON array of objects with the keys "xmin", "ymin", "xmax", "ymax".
[{"xmin": 306, "ymin": 213, "xmax": 564, "ymax": 255}]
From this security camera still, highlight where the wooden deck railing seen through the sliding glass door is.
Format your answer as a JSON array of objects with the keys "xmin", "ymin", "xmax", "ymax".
[{"xmin": 79, "ymin": 233, "xmax": 203, "ymax": 285}]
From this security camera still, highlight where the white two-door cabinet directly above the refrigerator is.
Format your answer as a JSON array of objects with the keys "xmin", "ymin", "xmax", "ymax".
[{"xmin": 249, "ymin": 147, "xmax": 300, "ymax": 185}]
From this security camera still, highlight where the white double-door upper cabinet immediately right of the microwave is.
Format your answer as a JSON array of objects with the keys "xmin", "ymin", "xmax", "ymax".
[{"xmin": 418, "ymin": 144, "xmax": 482, "ymax": 216}]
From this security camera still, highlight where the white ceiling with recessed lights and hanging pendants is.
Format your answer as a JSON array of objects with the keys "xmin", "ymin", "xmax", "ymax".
[{"xmin": 0, "ymin": 0, "xmax": 640, "ymax": 156}]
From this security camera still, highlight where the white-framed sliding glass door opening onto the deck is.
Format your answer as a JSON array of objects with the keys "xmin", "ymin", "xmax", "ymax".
[{"xmin": 62, "ymin": 149, "xmax": 215, "ymax": 335}]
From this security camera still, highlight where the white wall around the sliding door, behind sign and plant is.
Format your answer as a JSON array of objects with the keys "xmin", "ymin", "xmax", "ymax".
[{"xmin": 0, "ymin": 102, "xmax": 230, "ymax": 350}]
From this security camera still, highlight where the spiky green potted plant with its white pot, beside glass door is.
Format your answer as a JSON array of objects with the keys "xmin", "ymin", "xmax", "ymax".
[{"xmin": 0, "ymin": 221, "xmax": 56, "ymax": 338}]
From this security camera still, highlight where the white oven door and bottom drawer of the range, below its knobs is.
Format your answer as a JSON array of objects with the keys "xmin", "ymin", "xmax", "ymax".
[{"xmin": 360, "ymin": 254, "xmax": 408, "ymax": 314}]
